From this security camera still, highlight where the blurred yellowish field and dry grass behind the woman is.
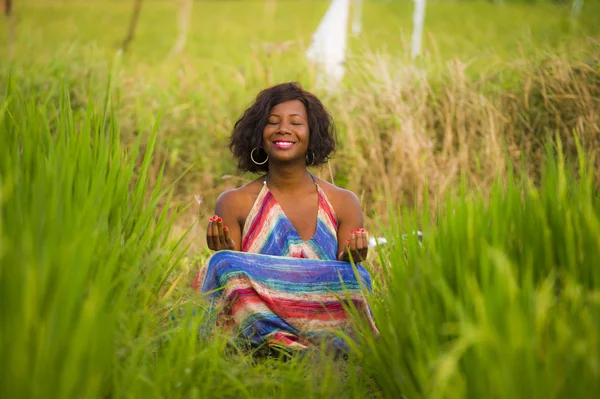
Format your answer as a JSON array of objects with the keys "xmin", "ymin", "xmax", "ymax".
[{"xmin": 0, "ymin": 0, "xmax": 600, "ymax": 244}]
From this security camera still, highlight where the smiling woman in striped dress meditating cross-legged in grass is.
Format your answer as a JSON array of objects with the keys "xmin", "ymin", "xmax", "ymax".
[{"xmin": 193, "ymin": 83, "xmax": 377, "ymax": 348}]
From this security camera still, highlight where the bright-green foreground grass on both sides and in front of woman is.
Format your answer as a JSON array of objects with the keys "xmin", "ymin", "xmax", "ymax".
[{"xmin": 0, "ymin": 78, "xmax": 600, "ymax": 398}]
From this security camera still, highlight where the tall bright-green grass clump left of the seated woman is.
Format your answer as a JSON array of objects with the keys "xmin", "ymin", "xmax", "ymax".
[{"xmin": 0, "ymin": 76, "xmax": 174, "ymax": 397}]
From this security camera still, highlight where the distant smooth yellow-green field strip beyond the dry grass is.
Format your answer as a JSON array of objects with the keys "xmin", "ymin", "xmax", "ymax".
[{"xmin": 0, "ymin": 0, "xmax": 600, "ymax": 65}]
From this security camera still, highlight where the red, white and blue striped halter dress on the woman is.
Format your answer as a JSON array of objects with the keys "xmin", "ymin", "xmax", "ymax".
[{"xmin": 192, "ymin": 176, "xmax": 377, "ymax": 349}]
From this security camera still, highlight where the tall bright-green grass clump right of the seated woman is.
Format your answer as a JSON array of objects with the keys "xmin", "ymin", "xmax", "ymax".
[{"xmin": 361, "ymin": 147, "xmax": 600, "ymax": 398}]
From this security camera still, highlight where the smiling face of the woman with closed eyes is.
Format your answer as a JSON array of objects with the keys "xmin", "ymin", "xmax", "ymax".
[{"xmin": 263, "ymin": 100, "xmax": 310, "ymax": 166}]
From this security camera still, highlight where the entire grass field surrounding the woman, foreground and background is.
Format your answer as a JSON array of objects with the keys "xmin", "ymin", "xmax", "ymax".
[{"xmin": 0, "ymin": 0, "xmax": 600, "ymax": 398}]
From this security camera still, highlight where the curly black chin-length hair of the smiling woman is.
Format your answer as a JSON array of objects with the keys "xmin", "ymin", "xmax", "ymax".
[{"xmin": 229, "ymin": 82, "xmax": 336, "ymax": 173}]
